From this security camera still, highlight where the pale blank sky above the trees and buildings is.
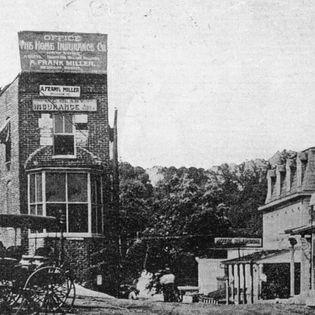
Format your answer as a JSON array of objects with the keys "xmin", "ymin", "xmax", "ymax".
[{"xmin": 0, "ymin": 0, "xmax": 315, "ymax": 168}]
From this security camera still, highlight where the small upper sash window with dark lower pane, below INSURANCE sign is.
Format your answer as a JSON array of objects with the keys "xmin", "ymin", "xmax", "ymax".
[{"xmin": 54, "ymin": 113, "xmax": 75, "ymax": 156}]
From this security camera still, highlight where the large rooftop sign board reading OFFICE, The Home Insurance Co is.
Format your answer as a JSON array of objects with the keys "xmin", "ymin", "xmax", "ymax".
[{"xmin": 18, "ymin": 31, "xmax": 107, "ymax": 74}]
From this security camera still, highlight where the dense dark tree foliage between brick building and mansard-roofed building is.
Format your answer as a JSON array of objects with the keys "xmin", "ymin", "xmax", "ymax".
[{"xmin": 119, "ymin": 160, "xmax": 268, "ymax": 286}]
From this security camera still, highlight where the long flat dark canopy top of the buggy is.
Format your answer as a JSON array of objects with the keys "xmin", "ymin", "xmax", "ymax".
[{"xmin": 0, "ymin": 213, "xmax": 58, "ymax": 230}]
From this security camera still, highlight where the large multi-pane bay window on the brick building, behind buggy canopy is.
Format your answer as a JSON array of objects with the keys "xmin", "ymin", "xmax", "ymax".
[{"xmin": 29, "ymin": 172, "xmax": 103, "ymax": 234}]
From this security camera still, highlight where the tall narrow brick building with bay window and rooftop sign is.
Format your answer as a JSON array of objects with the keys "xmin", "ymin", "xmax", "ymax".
[{"xmin": 0, "ymin": 32, "xmax": 117, "ymax": 292}]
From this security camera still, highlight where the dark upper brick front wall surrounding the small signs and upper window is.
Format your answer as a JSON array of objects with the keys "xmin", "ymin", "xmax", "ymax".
[{"xmin": 19, "ymin": 73, "xmax": 109, "ymax": 215}]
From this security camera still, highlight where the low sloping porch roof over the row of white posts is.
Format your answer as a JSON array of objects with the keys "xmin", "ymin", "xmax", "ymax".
[{"xmin": 221, "ymin": 249, "xmax": 290, "ymax": 265}]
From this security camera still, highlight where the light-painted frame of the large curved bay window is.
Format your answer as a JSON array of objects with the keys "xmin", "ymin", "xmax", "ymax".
[{"xmin": 27, "ymin": 169, "xmax": 104, "ymax": 238}]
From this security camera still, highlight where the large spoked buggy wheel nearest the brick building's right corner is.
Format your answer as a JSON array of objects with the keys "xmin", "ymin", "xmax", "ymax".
[{"xmin": 21, "ymin": 266, "xmax": 75, "ymax": 313}]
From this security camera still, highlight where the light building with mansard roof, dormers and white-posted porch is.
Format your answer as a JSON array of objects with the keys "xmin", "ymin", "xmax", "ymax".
[{"xmin": 223, "ymin": 148, "xmax": 315, "ymax": 303}]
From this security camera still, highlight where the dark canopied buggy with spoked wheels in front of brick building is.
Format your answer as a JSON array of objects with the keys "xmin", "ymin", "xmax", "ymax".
[{"xmin": 0, "ymin": 214, "xmax": 75, "ymax": 314}]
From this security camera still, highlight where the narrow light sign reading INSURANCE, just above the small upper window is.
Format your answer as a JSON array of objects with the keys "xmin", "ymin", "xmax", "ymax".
[{"xmin": 33, "ymin": 98, "xmax": 97, "ymax": 112}]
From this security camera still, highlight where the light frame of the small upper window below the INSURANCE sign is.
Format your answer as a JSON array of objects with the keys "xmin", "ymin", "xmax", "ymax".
[{"xmin": 52, "ymin": 112, "xmax": 77, "ymax": 158}]
